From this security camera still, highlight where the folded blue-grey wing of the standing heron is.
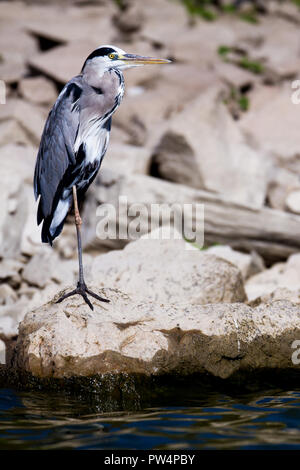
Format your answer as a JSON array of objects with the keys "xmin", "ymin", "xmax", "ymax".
[{"xmin": 34, "ymin": 77, "xmax": 82, "ymax": 224}]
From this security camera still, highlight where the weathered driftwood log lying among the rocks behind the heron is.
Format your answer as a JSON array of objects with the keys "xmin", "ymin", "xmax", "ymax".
[{"xmin": 84, "ymin": 170, "xmax": 300, "ymax": 262}]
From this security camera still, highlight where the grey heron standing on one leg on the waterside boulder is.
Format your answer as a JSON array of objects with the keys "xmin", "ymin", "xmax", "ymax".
[{"xmin": 34, "ymin": 45, "xmax": 170, "ymax": 310}]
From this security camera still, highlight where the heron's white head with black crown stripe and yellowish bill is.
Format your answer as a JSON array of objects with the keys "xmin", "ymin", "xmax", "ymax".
[{"xmin": 82, "ymin": 45, "xmax": 171, "ymax": 74}]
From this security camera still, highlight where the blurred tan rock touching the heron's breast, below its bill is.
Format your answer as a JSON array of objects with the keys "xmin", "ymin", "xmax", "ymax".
[{"xmin": 114, "ymin": 67, "xmax": 220, "ymax": 147}]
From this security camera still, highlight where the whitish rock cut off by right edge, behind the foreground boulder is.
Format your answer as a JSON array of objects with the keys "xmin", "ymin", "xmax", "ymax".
[{"xmin": 245, "ymin": 254, "xmax": 300, "ymax": 301}]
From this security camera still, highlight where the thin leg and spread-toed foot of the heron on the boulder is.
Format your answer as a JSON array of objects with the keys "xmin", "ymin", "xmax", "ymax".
[{"xmin": 56, "ymin": 185, "xmax": 109, "ymax": 310}]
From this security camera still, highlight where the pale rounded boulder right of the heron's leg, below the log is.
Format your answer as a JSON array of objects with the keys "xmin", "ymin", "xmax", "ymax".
[{"xmin": 92, "ymin": 232, "xmax": 246, "ymax": 305}]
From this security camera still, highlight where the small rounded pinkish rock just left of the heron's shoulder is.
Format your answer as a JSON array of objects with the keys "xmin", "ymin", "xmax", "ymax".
[{"xmin": 18, "ymin": 77, "xmax": 57, "ymax": 104}]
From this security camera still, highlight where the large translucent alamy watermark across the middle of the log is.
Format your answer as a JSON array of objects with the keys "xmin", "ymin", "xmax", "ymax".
[{"xmin": 96, "ymin": 196, "xmax": 204, "ymax": 248}]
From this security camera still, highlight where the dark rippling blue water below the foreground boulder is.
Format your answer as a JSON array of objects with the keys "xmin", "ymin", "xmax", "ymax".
[{"xmin": 0, "ymin": 389, "xmax": 300, "ymax": 450}]
